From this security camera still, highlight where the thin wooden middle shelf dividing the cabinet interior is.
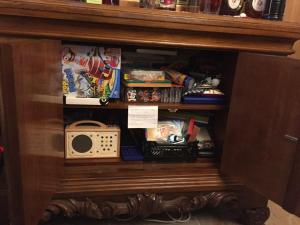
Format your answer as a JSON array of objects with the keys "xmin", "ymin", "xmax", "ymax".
[{"xmin": 64, "ymin": 102, "xmax": 225, "ymax": 111}]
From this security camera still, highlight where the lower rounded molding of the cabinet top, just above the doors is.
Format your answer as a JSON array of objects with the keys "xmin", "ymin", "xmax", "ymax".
[{"xmin": 0, "ymin": 16, "xmax": 295, "ymax": 54}]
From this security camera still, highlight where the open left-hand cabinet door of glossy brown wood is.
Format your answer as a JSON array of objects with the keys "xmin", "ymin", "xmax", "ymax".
[{"xmin": 0, "ymin": 40, "xmax": 64, "ymax": 225}]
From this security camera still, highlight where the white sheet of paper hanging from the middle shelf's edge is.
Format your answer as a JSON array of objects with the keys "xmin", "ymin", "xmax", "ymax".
[{"xmin": 128, "ymin": 105, "xmax": 158, "ymax": 128}]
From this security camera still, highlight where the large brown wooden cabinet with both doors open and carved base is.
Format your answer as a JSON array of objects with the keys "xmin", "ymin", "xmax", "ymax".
[{"xmin": 0, "ymin": 0, "xmax": 300, "ymax": 225}]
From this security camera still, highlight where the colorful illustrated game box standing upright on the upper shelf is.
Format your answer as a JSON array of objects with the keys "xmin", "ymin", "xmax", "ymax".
[{"xmin": 62, "ymin": 45, "xmax": 121, "ymax": 98}]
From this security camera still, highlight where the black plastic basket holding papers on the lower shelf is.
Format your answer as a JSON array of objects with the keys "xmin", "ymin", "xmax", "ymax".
[{"xmin": 143, "ymin": 141, "xmax": 198, "ymax": 162}]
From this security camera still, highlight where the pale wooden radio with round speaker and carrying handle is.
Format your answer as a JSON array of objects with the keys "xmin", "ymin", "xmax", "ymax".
[{"xmin": 65, "ymin": 120, "xmax": 120, "ymax": 159}]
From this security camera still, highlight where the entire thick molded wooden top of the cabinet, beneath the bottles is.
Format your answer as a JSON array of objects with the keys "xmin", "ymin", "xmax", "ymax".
[{"xmin": 0, "ymin": 0, "xmax": 300, "ymax": 55}]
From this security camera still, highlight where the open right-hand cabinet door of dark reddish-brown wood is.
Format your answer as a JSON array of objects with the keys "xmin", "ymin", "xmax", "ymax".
[{"xmin": 221, "ymin": 53, "xmax": 300, "ymax": 214}]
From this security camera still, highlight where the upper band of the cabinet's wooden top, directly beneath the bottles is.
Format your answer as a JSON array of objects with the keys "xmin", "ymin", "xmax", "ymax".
[{"xmin": 0, "ymin": 0, "xmax": 300, "ymax": 38}]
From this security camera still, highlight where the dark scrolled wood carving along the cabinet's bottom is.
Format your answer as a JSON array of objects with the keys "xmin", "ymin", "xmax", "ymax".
[{"xmin": 42, "ymin": 192, "xmax": 237, "ymax": 222}]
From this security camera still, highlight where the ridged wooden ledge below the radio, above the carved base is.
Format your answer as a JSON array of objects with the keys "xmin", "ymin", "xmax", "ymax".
[{"xmin": 56, "ymin": 159, "xmax": 241, "ymax": 198}]
